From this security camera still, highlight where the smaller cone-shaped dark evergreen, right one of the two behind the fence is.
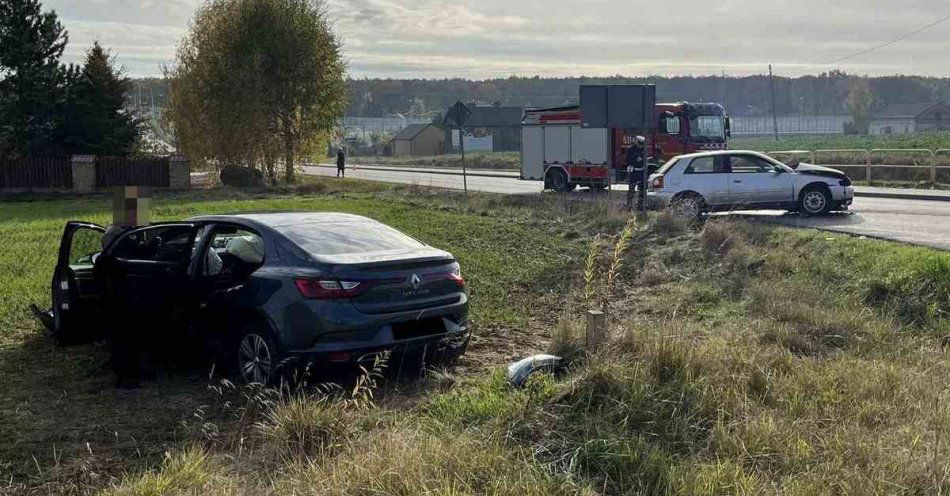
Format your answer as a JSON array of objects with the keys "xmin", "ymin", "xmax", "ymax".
[{"xmin": 57, "ymin": 41, "xmax": 139, "ymax": 156}]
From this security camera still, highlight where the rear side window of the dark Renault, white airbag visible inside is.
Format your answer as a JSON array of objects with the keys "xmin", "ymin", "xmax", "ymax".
[{"xmin": 202, "ymin": 225, "xmax": 265, "ymax": 279}]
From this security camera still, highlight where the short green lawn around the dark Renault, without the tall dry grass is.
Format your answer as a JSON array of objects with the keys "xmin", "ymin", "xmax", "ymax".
[{"xmin": 0, "ymin": 180, "xmax": 616, "ymax": 487}]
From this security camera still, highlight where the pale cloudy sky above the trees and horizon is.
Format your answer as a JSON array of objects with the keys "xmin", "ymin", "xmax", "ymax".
[{"xmin": 43, "ymin": 0, "xmax": 950, "ymax": 79}]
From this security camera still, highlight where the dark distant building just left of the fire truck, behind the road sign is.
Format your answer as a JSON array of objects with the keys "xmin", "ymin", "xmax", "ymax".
[{"xmin": 442, "ymin": 104, "xmax": 523, "ymax": 152}]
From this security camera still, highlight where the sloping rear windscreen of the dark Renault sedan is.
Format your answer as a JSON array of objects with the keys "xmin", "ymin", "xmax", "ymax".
[{"xmin": 276, "ymin": 222, "xmax": 426, "ymax": 255}]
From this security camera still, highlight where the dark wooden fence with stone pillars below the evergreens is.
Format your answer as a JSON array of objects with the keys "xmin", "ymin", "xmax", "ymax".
[{"xmin": 0, "ymin": 155, "xmax": 191, "ymax": 193}]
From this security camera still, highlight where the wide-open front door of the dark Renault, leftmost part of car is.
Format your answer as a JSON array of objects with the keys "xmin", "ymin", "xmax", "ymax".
[{"xmin": 43, "ymin": 221, "xmax": 106, "ymax": 344}]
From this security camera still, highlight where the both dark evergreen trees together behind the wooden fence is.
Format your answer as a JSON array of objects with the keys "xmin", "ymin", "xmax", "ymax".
[{"xmin": 0, "ymin": 0, "xmax": 139, "ymax": 158}]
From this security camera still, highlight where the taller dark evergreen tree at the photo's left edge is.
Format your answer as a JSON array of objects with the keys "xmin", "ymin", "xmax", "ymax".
[{"xmin": 0, "ymin": 0, "xmax": 67, "ymax": 156}]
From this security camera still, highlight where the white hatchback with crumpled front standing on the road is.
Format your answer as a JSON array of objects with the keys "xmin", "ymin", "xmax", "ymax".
[{"xmin": 647, "ymin": 150, "xmax": 854, "ymax": 216}]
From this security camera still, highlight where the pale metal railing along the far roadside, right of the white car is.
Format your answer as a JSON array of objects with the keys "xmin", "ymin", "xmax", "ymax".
[{"xmin": 764, "ymin": 148, "xmax": 950, "ymax": 188}]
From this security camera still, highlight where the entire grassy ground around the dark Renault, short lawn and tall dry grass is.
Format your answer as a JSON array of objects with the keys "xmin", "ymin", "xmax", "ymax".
[{"xmin": 0, "ymin": 181, "xmax": 950, "ymax": 496}]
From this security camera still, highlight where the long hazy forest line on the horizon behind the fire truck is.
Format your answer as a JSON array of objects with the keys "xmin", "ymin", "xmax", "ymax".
[{"xmin": 347, "ymin": 70, "xmax": 950, "ymax": 117}]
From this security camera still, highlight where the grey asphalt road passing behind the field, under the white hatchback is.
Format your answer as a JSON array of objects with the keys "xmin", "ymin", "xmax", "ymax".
[{"xmin": 304, "ymin": 166, "xmax": 950, "ymax": 250}]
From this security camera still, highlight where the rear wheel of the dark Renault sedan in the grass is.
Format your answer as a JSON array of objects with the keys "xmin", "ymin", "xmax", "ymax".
[{"xmin": 232, "ymin": 324, "xmax": 284, "ymax": 386}]
